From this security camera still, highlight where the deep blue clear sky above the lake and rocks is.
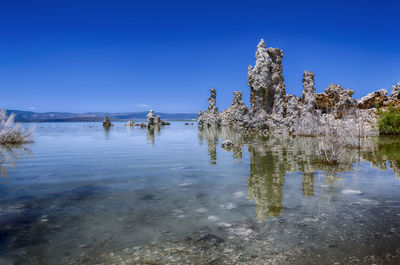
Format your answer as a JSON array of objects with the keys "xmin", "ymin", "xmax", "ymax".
[{"xmin": 0, "ymin": 0, "xmax": 400, "ymax": 112}]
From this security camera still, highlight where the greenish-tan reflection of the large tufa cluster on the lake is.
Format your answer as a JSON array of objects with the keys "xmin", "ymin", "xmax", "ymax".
[{"xmin": 199, "ymin": 126, "xmax": 400, "ymax": 222}]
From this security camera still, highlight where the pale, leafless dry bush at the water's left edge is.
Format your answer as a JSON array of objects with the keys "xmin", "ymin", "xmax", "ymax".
[{"xmin": 0, "ymin": 110, "xmax": 32, "ymax": 144}]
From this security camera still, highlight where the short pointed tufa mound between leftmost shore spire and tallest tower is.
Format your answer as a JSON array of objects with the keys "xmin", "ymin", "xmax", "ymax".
[{"xmin": 220, "ymin": 91, "xmax": 249, "ymax": 126}]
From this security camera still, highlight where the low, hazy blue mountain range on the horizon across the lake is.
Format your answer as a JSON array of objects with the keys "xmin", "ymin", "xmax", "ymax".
[{"xmin": 6, "ymin": 110, "xmax": 197, "ymax": 122}]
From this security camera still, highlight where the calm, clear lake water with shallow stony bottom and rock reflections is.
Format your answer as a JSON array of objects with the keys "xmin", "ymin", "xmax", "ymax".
[{"xmin": 0, "ymin": 122, "xmax": 400, "ymax": 264}]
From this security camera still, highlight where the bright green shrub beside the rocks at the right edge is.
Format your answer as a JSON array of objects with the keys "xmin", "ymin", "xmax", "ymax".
[{"xmin": 378, "ymin": 106, "xmax": 400, "ymax": 134}]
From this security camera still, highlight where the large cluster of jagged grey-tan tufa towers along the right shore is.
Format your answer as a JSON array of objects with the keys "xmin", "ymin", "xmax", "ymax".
[{"xmin": 198, "ymin": 39, "xmax": 400, "ymax": 135}]
